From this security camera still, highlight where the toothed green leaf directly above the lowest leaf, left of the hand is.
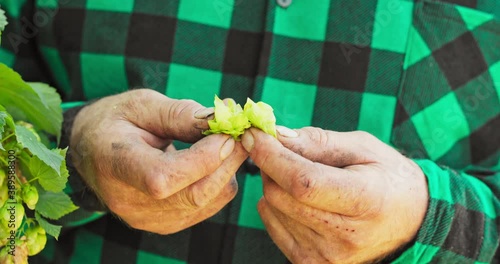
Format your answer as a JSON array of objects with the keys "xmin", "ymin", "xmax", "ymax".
[{"xmin": 29, "ymin": 149, "xmax": 69, "ymax": 192}]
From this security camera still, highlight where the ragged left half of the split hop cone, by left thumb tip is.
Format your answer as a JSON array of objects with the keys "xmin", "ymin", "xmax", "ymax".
[{"xmin": 203, "ymin": 96, "xmax": 251, "ymax": 140}]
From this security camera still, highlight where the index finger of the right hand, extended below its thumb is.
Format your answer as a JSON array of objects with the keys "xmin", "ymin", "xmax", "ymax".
[{"xmin": 242, "ymin": 129, "xmax": 366, "ymax": 210}]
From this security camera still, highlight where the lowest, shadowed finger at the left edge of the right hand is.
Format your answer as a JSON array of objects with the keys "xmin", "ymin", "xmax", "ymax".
[{"xmin": 257, "ymin": 198, "xmax": 296, "ymax": 261}]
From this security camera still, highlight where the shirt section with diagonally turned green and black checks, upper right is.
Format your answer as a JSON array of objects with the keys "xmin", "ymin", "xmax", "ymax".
[{"xmin": 391, "ymin": 1, "xmax": 500, "ymax": 168}]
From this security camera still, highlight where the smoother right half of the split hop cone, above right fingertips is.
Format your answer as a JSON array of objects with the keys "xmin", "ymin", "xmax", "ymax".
[{"xmin": 243, "ymin": 98, "xmax": 277, "ymax": 137}]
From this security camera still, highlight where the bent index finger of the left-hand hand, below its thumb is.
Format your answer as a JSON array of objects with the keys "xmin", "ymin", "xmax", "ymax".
[{"xmin": 108, "ymin": 135, "xmax": 235, "ymax": 199}]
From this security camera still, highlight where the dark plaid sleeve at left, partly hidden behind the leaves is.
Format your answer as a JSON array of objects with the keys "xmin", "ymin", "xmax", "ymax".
[{"xmin": 0, "ymin": 0, "xmax": 107, "ymax": 227}]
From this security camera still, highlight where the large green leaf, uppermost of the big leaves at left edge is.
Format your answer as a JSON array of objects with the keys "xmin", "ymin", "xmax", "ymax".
[{"xmin": 0, "ymin": 63, "xmax": 62, "ymax": 138}]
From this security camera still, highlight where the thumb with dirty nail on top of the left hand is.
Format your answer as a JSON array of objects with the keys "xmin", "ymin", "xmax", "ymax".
[{"xmin": 116, "ymin": 89, "xmax": 213, "ymax": 142}]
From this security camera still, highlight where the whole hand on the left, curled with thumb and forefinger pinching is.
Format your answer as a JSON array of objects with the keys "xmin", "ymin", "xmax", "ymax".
[{"xmin": 70, "ymin": 89, "xmax": 248, "ymax": 234}]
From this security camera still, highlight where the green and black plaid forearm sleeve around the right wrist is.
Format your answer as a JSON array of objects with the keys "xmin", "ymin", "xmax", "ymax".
[{"xmin": 393, "ymin": 160, "xmax": 500, "ymax": 264}]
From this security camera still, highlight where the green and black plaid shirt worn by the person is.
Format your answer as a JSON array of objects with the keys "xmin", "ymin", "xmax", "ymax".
[{"xmin": 0, "ymin": 0, "xmax": 500, "ymax": 264}]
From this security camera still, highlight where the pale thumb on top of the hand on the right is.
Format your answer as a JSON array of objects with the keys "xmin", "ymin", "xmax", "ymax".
[{"xmin": 277, "ymin": 126, "xmax": 387, "ymax": 167}]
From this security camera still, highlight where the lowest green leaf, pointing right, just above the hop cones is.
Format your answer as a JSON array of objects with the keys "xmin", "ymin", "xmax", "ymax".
[{"xmin": 35, "ymin": 191, "xmax": 78, "ymax": 220}]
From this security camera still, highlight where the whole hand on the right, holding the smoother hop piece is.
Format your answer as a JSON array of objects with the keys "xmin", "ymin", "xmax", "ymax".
[{"xmin": 242, "ymin": 128, "xmax": 428, "ymax": 263}]
